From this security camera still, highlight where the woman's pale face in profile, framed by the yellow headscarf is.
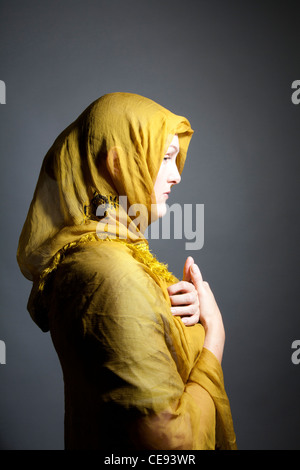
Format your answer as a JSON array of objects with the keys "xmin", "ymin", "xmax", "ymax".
[{"xmin": 154, "ymin": 135, "xmax": 181, "ymax": 217}]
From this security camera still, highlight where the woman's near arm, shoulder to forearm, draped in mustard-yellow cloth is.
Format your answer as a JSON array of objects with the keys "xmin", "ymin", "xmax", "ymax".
[{"xmin": 52, "ymin": 244, "xmax": 235, "ymax": 450}]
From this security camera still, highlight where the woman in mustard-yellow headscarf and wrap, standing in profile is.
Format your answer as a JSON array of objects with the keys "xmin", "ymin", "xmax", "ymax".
[{"xmin": 18, "ymin": 93, "xmax": 236, "ymax": 451}]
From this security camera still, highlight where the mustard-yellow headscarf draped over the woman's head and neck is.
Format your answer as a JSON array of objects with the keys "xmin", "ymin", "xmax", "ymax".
[{"xmin": 17, "ymin": 93, "xmax": 193, "ymax": 281}]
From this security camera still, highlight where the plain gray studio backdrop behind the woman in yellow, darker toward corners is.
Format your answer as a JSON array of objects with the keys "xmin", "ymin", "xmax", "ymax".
[{"xmin": 0, "ymin": 0, "xmax": 300, "ymax": 449}]
